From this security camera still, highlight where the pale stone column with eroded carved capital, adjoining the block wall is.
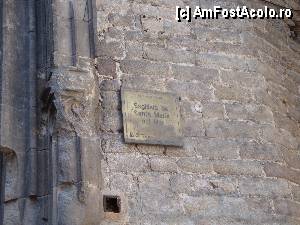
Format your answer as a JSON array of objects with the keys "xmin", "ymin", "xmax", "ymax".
[{"xmin": 47, "ymin": 0, "xmax": 101, "ymax": 225}]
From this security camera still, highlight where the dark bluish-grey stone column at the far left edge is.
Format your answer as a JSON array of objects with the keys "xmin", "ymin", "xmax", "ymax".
[{"xmin": 0, "ymin": 0, "xmax": 38, "ymax": 225}]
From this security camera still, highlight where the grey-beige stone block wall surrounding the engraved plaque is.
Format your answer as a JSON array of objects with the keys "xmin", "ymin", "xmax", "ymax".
[{"xmin": 96, "ymin": 0, "xmax": 300, "ymax": 225}]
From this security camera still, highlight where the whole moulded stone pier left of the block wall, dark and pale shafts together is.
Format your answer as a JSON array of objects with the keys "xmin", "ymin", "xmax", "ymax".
[{"xmin": 0, "ymin": 0, "xmax": 101, "ymax": 225}]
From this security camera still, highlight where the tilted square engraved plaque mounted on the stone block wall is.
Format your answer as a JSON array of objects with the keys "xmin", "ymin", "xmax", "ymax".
[{"xmin": 121, "ymin": 89, "xmax": 183, "ymax": 146}]
